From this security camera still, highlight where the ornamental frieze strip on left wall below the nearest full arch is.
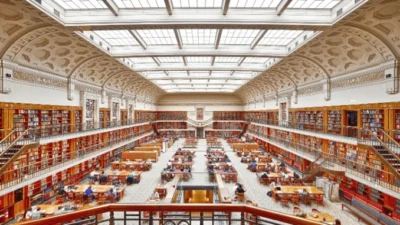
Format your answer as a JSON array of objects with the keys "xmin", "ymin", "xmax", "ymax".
[{"xmin": 13, "ymin": 71, "xmax": 67, "ymax": 89}]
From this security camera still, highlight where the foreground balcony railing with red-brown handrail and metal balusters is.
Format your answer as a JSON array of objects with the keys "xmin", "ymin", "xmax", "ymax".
[{"xmin": 17, "ymin": 204, "xmax": 324, "ymax": 225}]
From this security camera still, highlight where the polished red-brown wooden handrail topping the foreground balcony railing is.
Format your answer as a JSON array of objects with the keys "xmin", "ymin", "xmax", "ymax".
[{"xmin": 19, "ymin": 204, "xmax": 323, "ymax": 225}]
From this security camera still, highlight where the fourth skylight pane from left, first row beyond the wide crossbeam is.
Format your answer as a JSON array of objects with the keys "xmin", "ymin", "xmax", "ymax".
[{"xmin": 220, "ymin": 29, "xmax": 260, "ymax": 45}]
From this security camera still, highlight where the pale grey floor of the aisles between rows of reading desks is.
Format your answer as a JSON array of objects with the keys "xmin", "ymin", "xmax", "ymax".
[{"xmin": 95, "ymin": 139, "xmax": 364, "ymax": 225}]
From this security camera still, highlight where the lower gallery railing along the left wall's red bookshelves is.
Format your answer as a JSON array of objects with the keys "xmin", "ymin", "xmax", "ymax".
[{"xmin": 0, "ymin": 131, "xmax": 152, "ymax": 189}]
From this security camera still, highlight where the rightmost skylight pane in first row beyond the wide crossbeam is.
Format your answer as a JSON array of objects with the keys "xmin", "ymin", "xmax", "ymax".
[{"xmin": 258, "ymin": 30, "xmax": 304, "ymax": 46}]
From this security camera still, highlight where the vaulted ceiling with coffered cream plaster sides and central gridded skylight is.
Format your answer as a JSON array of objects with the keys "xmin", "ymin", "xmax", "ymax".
[{"xmin": 0, "ymin": 0, "xmax": 400, "ymax": 101}]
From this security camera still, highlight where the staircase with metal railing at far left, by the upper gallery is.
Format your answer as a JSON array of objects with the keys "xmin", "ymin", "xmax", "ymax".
[{"xmin": 0, "ymin": 130, "xmax": 39, "ymax": 174}]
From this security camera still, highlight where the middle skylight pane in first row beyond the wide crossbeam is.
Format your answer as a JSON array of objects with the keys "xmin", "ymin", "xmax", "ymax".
[{"xmin": 179, "ymin": 29, "xmax": 217, "ymax": 45}]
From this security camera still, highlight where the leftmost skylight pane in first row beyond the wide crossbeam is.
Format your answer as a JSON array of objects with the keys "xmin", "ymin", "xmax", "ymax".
[{"xmin": 93, "ymin": 30, "xmax": 138, "ymax": 46}]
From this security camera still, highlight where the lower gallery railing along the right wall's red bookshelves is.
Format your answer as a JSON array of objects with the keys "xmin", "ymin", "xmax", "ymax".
[{"xmin": 248, "ymin": 131, "xmax": 400, "ymax": 192}]
